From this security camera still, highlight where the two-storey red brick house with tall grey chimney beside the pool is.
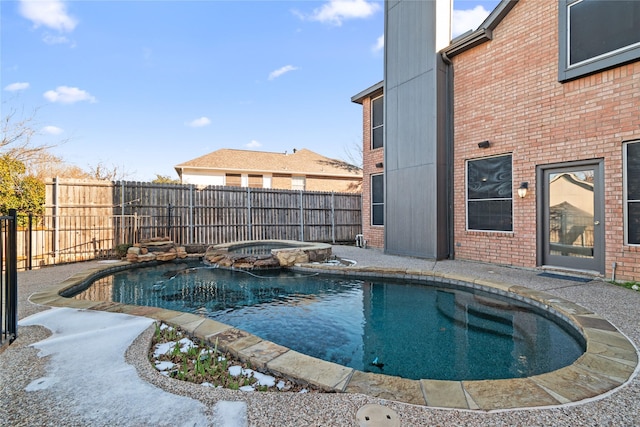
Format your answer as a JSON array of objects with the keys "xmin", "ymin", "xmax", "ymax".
[{"xmin": 352, "ymin": 0, "xmax": 640, "ymax": 281}]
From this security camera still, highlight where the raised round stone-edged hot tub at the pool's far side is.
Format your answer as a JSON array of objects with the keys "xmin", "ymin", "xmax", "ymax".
[{"xmin": 204, "ymin": 240, "xmax": 331, "ymax": 270}]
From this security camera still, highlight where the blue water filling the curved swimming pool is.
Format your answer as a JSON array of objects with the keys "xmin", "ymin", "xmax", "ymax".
[{"xmin": 76, "ymin": 264, "xmax": 584, "ymax": 380}]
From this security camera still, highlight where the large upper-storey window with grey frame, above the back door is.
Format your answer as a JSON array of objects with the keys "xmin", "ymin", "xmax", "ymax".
[{"xmin": 558, "ymin": 0, "xmax": 640, "ymax": 81}]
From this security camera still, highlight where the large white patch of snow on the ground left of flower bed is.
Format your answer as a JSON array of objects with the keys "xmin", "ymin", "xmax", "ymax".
[{"xmin": 19, "ymin": 308, "xmax": 210, "ymax": 426}]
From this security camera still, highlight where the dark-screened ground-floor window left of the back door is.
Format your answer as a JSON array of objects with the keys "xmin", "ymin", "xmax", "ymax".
[{"xmin": 467, "ymin": 155, "xmax": 513, "ymax": 231}]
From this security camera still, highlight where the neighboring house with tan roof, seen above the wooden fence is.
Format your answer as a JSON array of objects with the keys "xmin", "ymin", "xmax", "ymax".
[{"xmin": 175, "ymin": 149, "xmax": 362, "ymax": 193}]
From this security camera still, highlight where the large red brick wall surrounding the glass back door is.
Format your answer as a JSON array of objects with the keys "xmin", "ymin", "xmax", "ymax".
[{"xmin": 452, "ymin": 0, "xmax": 640, "ymax": 280}]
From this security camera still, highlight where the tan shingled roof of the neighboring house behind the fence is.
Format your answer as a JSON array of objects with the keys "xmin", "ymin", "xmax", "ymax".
[{"xmin": 175, "ymin": 148, "xmax": 362, "ymax": 178}]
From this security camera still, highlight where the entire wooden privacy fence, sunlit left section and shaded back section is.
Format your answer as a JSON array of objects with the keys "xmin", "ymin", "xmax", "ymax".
[{"xmin": 18, "ymin": 179, "xmax": 362, "ymax": 269}]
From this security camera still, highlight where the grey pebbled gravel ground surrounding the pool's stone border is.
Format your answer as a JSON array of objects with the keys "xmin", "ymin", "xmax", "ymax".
[{"xmin": 0, "ymin": 246, "xmax": 640, "ymax": 426}]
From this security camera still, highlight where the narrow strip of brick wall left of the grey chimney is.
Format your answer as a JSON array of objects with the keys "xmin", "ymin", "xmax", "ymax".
[{"xmin": 362, "ymin": 95, "xmax": 384, "ymax": 248}]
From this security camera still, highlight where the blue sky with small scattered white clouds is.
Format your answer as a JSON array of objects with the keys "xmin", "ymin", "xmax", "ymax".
[{"xmin": 0, "ymin": 0, "xmax": 499, "ymax": 181}]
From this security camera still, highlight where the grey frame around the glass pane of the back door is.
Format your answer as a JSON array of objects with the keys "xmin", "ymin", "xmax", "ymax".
[{"xmin": 536, "ymin": 159, "xmax": 606, "ymax": 274}]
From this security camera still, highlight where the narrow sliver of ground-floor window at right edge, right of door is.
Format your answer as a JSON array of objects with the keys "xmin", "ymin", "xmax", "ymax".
[{"xmin": 624, "ymin": 141, "xmax": 640, "ymax": 245}]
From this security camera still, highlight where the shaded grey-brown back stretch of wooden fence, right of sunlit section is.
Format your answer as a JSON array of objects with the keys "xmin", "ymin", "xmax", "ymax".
[{"xmin": 114, "ymin": 182, "xmax": 362, "ymax": 244}]
